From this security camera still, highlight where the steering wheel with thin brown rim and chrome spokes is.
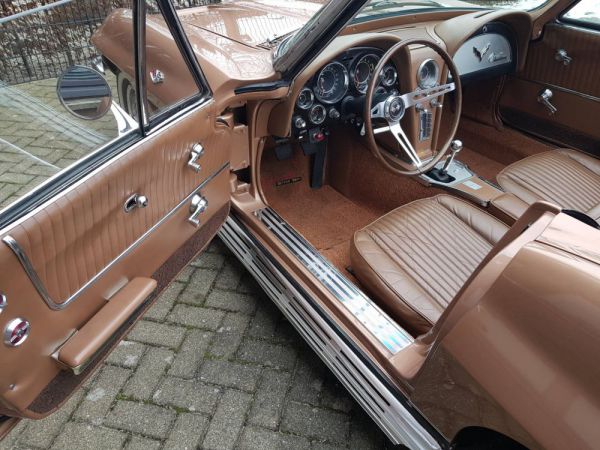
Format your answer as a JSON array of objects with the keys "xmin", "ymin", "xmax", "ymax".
[{"xmin": 363, "ymin": 39, "xmax": 462, "ymax": 175}]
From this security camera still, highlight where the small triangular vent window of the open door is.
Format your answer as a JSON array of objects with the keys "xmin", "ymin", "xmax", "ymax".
[{"xmin": 146, "ymin": 0, "xmax": 199, "ymax": 117}]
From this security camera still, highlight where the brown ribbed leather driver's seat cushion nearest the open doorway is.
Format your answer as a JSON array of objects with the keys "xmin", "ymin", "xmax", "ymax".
[{"xmin": 350, "ymin": 195, "xmax": 508, "ymax": 334}]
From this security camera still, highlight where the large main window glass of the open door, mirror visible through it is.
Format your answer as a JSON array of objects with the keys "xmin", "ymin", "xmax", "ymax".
[{"xmin": 0, "ymin": 0, "xmax": 137, "ymax": 209}]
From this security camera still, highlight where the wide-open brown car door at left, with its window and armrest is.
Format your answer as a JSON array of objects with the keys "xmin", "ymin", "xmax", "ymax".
[{"xmin": 0, "ymin": 0, "xmax": 231, "ymax": 419}]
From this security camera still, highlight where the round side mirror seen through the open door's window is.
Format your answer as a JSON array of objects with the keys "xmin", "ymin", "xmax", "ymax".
[{"xmin": 56, "ymin": 66, "xmax": 112, "ymax": 120}]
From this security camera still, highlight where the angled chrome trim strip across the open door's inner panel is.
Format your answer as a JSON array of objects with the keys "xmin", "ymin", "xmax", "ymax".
[{"xmin": 2, "ymin": 162, "xmax": 229, "ymax": 311}]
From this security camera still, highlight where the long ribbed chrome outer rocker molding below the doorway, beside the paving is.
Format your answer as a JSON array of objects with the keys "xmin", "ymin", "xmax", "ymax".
[{"xmin": 219, "ymin": 216, "xmax": 441, "ymax": 449}]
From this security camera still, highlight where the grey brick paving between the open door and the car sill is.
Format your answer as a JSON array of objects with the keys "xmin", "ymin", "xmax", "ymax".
[{"xmin": 0, "ymin": 239, "xmax": 391, "ymax": 450}]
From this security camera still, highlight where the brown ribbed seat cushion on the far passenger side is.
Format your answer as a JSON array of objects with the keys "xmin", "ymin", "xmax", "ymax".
[{"xmin": 497, "ymin": 149, "xmax": 600, "ymax": 221}]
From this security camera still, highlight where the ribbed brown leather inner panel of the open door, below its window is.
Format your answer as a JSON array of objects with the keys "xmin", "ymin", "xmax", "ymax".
[{"xmin": 0, "ymin": 103, "xmax": 231, "ymax": 418}]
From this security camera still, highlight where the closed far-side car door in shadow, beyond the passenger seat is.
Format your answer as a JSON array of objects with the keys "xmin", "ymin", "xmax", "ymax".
[{"xmin": 500, "ymin": 0, "xmax": 600, "ymax": 156}]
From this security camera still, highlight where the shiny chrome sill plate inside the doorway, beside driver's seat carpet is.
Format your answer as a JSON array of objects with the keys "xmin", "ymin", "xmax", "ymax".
[{"xmin": 255, "ymin": 208, "xmax": 413, "ymax": 353}]
